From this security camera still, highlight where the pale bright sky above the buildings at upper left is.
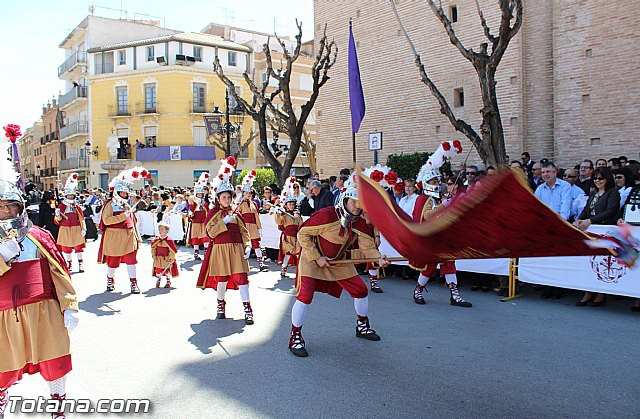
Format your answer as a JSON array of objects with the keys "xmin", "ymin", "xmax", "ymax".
[{"xmin": 0, "ymin": 0, "xmax": 313, "ymax": 132}]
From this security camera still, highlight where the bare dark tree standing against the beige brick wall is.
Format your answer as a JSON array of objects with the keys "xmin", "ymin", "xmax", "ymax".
[{"xmin": 390, "ymin": 0, "xmax": 523, "ymax": 165}]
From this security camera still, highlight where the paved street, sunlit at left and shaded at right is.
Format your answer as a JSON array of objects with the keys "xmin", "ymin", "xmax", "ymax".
[{"xmin": 7, "ymin": 241, "xmax": 640, "ymax": 419}]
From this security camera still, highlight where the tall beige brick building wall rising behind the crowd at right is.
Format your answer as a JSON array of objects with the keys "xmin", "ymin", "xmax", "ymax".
[{"xmin": 314, "ymin": 0, "xmax": 640, "ymax": 176}]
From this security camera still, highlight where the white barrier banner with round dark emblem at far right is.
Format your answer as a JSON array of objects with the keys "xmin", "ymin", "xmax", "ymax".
[{"xmin": 518, "ymin": 225, "xmax": 640, "ymax": 297}]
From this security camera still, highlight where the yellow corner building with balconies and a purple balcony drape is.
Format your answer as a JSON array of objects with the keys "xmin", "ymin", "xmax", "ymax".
[{"xmin": 87, "ymin": 33, "xmax": 255, "ymax": 188}]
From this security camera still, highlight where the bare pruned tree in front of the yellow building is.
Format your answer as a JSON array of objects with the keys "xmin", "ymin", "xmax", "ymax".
[{"xmin": 214, "ymin": 20, "xmax": 338, "ymax": 185}]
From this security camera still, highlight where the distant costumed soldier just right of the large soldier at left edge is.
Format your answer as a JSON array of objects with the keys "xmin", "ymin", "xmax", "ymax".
[{"xmin": 53, "ymin": 173, "xmax": 87, "ymax": 272}]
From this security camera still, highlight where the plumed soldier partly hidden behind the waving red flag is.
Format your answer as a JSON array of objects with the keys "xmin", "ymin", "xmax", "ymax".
[{"xmin": 411, "ymin": 142, "xmax": 472, "ymax": 307}]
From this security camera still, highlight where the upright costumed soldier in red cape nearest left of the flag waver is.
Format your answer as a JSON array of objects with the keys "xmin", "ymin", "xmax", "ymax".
[{"xmin": 197, "ymin": 157, "xmax": 253, "ymax": 324}]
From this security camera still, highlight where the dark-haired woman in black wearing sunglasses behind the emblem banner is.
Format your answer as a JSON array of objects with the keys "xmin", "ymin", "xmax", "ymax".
[{"xmin": 573, "ymin": 167, "xmax": 620, "ymax": 307}]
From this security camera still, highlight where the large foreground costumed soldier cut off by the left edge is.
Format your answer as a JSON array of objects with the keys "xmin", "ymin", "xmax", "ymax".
[{"xmin": 0, "ymin": 129, "xmax": 78, "ymax": 419}]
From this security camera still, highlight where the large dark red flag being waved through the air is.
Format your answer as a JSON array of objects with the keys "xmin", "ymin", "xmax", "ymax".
[{"xmin": 358, "ymin": 170, "xmax": 615, "ymax": 265}]
